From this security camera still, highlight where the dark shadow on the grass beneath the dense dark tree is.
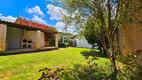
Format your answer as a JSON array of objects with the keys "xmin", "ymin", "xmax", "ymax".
[{"xmin": 81, "ymin": 51, "xmax": 108, "ymax": 59}]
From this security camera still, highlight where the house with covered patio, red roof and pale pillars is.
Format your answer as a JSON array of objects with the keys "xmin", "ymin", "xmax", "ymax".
[{"xmin": 0, "ymin": 17, "xmax": 58, "ymax": 52}]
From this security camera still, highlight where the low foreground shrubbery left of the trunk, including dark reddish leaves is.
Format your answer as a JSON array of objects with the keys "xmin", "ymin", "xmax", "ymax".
[{"xmin": 39, "ymin": 57, "xmax": 107, "ymax": 80}]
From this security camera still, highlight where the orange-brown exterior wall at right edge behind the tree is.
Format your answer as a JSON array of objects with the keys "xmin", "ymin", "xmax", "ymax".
[{"xmin": 119, "ymin": 9, "xmax": 142, "ymax": 54}]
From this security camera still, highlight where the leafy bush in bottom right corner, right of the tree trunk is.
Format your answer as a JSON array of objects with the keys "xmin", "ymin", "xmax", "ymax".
[{"xmin": 117, "ymin": 54, "xmax": 142, "ymax": 80}]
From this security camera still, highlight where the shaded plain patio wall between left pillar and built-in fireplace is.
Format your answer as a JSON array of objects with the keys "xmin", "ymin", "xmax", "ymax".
[{"xmin": 6, "ymin": 26, "xmax": 23, "ymax": 49}]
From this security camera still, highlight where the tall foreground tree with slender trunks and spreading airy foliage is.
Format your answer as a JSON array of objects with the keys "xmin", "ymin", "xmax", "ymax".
[{"xmin": 52, "ymin": 0, "xmax": 141, "ymax": 73}]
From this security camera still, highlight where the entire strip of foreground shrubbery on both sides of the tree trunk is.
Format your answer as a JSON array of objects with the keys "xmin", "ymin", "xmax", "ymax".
[{"xmin": 39, "ymin": 55, "xmax": 142, "ymax": 80}]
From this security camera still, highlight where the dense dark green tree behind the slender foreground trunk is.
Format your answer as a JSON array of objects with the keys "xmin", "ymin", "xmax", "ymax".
[{"xmin": 81, "ymin": 19, "xmax": 109, "ymax": 53}]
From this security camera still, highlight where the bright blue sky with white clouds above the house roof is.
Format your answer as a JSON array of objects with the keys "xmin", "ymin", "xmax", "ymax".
[{"xmin": 0, "ymin": 0, "xmax": 76, "ymax": 34}]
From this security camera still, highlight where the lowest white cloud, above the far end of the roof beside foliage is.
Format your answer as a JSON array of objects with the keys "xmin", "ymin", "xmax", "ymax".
[{"xmin": 55, "ymin": 22, "xmax": 77, "ymax": 34}]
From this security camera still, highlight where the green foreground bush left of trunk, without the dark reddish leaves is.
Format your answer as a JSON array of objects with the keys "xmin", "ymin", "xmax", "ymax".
[{"xmin": 60, "ymin": 57, "xmax": 107, "ymax": 80}]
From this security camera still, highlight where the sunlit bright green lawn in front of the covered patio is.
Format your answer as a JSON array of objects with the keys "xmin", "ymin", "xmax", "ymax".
[{"xmin": 0, "ymin": 48, "xmax": 110, "ymax": 80}]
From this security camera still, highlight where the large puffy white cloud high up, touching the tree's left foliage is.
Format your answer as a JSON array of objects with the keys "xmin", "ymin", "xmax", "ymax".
[{"xmin": 47, "ymin": 4, "xmax": 68, "ymax": 20}]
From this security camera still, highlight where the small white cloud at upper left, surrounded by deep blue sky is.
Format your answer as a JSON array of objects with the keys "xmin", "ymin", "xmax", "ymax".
[{"xmin": 27, "ymin": 6, "xmax": 44, "ymax": 16}]
